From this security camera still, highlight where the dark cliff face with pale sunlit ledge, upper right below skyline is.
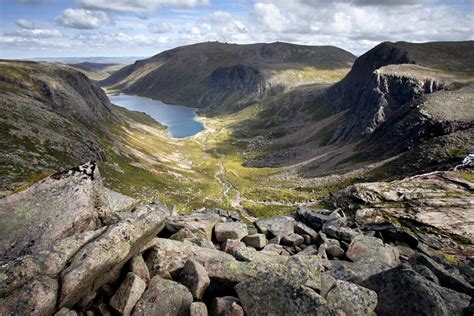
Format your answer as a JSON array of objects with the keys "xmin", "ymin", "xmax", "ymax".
[{"xmin": 326, "ymin": 42, "xmax": 474, "ymax": 143}]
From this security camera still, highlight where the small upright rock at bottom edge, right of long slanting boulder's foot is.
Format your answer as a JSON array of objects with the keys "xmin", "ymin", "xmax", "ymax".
[{"xmin": 110, "ymin": 272, "xmax": 146, "ymax": 315}]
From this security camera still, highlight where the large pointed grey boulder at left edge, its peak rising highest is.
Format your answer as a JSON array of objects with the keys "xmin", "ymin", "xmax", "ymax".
[{"xmin": 0, "ymin": 162, "xmax": 111, "ymax": 263}]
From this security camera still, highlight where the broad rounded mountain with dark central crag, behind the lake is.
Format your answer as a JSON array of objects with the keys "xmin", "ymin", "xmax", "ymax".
[{"xmin": 100, "ymin": 42, "xmax": 355, "ymax": 112}]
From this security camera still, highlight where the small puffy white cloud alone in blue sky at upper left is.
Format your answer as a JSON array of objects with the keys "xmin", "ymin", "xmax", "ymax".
[{"xmin": 55, "ymin": 8, "xmax": 111, "ymax": 29}]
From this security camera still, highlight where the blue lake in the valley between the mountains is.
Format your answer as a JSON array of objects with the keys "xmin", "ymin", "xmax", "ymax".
[{"xmin": 108, "ymin": 94, "xmax": 205, "ymax": 138}]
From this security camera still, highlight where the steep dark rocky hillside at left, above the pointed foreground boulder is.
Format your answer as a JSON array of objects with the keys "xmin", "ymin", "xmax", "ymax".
[{"xmin": 0, "ymin": 61, "xmax": 116, "ymax": 193}]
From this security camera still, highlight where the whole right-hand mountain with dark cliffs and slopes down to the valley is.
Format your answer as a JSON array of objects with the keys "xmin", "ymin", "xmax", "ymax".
[{"xmin": 246, "ymin": 41, "xmax": 474, "ymax": 179}]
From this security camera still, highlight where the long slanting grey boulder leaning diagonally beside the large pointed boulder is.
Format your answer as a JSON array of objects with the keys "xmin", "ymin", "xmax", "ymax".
[{"xmin": 59, "ymin": 204, "xmax": 169, "ymax": 307}]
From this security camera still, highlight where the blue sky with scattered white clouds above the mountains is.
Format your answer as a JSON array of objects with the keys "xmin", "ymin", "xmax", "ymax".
[{"xmin": 0, "ymin": 0, "xmax": 474, "ymax": 59}]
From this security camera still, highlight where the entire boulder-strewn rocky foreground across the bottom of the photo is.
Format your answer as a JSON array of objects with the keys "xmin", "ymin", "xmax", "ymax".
[{"xmin": 0, "ymin": 163, "xmax": 474, "ymax": 315}]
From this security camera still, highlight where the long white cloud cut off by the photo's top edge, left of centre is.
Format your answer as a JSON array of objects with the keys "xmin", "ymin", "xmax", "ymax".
[{"xmin": 76, "ymin": 0, "xmax": 210, "ymax": 12}]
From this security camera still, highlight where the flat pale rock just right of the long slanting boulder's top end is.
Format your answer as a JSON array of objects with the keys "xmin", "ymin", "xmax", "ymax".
[{"xmin": 166, "ymin": 212, "xmax": 220, "ymax": 240}]
